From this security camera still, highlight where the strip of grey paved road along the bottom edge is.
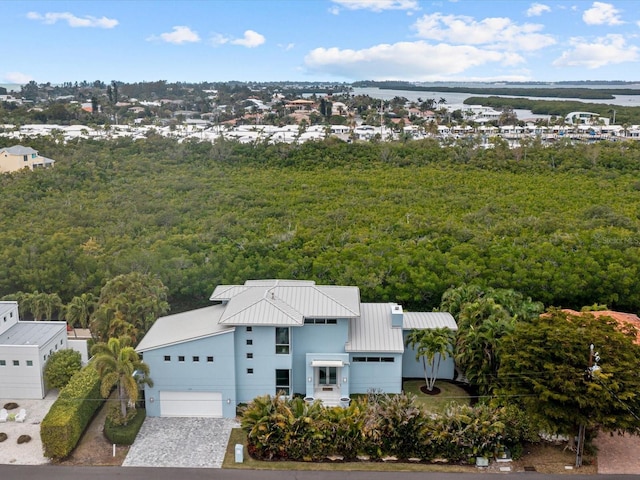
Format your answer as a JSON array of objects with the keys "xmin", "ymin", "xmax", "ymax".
[{"xmin": 0, "ymin": 465, "xmax": 632, "ymax": 480}]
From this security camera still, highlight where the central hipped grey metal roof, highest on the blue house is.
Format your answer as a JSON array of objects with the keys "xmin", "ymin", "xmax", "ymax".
[{"xmin": 210, "ymin": 280, "xmax": 360, "ymax": 326}]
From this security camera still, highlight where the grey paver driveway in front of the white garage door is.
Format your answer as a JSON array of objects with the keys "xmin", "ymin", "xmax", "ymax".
[{"xmin": 122, "ymin": 417, "xmax": 239, "ymax": 468}]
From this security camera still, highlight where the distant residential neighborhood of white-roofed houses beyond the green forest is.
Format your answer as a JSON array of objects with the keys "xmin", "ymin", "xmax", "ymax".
[{"xmin": 0, "ymin": 81, "xmax": 640, "ymax": 148}]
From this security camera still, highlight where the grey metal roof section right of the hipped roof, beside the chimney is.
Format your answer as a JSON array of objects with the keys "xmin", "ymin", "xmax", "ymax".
[{"xmin": 345, "ymin": 303, "xmax": 404, "ymax": 353}]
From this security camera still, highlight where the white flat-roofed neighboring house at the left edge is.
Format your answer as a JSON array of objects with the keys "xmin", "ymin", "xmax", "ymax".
[{"xmin": 0, "ymin": 301, "xmax": 68, "ymax": 399}]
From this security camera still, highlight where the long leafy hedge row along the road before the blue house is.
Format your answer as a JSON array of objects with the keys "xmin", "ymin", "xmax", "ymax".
[{"xmin": 242, "ymin": 395, "xmax": 537, "ymax": 462}]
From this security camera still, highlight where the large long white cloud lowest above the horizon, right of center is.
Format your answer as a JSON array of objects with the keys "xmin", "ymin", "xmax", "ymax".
[{"xmin": 305, "ymin": 41, "xmax": 523, "ymax": 81}]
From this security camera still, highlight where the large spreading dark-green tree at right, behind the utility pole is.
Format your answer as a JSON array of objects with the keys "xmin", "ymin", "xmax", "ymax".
[{"xmin": 499, "ymin": 309, "xmax": 640, "ymax": 437}]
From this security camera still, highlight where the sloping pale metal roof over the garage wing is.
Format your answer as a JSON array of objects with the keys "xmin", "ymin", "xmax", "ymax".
[{"xmin": 136, "ymin": 305, "xmax": 234, "ymax": 352}]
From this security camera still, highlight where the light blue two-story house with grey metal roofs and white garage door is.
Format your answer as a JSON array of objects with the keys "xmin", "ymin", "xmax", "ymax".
[{"xmin": 136, "ymin": 280, "xmax": 457, "ymax": 418}]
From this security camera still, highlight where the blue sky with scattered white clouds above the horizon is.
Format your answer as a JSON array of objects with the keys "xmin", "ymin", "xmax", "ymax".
[{"xmin": 0, "ymin": 0, "xmax": 640, "ymax": 83}]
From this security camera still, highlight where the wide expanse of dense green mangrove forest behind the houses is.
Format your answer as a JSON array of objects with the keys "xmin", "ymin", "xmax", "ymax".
[{"xmin": 0, "ymin": 135, "xmax": 640, "ymax": 311}]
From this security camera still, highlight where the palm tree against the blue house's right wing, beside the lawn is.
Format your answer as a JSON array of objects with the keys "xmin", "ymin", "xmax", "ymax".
[{"xmin": 405, "ymin": 327, "xmax": 454, "ymax": 391}]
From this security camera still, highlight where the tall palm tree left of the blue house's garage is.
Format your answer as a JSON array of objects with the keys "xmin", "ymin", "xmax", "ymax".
[{"xmin": 91, "ymin": 337, "xmax": 153, "ymax": 423}]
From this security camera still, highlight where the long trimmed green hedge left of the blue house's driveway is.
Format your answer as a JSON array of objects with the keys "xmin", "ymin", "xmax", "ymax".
[{"xmin": 40, "ymin": 365, "xmax": 104, "ymax": 460}]
